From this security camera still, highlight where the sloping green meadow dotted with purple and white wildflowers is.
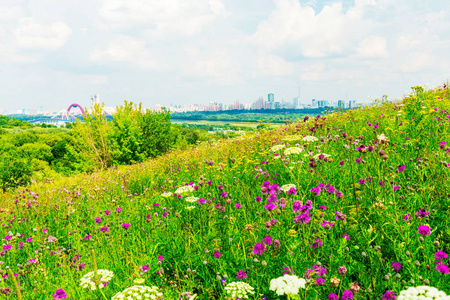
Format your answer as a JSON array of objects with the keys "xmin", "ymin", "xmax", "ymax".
[{"xmin": 0, "ymin": 85, "xmax": 450, "ymax": 300}]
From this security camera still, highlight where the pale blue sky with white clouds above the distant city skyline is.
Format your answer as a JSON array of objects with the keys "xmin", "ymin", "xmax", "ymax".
[{"xmin": 0, "ymin": 0, "xmax": 450, "ymax": 112}]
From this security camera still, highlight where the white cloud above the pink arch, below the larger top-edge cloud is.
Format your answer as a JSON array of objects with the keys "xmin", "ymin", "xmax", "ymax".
[{"xmin": 89, "ymin": 36, "xmax": 161, "ymax": 69}]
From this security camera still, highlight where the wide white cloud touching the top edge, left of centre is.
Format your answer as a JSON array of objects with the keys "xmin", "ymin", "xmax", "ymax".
[{"xmin": 99, "ymin": 0, "xmax": 226, "ymax": 38}]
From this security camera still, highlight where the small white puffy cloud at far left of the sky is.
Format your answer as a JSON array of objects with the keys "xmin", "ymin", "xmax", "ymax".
[{"xmin": 13, "ymin": 18, "xmax": 72, "ymax": 50}]
